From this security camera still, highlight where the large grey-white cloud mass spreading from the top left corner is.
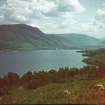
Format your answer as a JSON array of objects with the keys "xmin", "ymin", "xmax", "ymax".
[{"xmin": 0, "ymin": 0, "xmax": 85, "ymax": 24}]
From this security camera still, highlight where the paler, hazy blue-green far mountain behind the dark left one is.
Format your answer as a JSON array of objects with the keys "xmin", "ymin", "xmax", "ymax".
[{"xmin": 47, "ymin": 33, "xmax": 100, "ymax": 48}]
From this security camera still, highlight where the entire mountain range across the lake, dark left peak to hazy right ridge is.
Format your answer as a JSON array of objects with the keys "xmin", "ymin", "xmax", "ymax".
[{"xmin": 0, "ymin": 24, "xmax": 100, "ymax": 50}]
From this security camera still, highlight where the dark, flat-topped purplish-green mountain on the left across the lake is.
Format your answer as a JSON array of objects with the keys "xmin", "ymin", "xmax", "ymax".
[{"xmin": 0, "ymin": 24, "xmax": 65, "ymax": 50}]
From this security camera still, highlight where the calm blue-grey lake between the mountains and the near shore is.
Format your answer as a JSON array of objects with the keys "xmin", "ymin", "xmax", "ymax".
[{"xmin": 0, "ymin": 50, "xmax": 85, "ymax": 75}]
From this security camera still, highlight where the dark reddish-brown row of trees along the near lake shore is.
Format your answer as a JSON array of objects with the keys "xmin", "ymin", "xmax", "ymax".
[{"xmin": 0, "ymin": 66, "xmax": 96, "ymax": 95}]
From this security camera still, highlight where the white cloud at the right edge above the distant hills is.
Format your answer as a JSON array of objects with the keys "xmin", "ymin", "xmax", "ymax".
[{"xmin": 80, "ymin": 4, "xmax": 105, "ymax": 38}]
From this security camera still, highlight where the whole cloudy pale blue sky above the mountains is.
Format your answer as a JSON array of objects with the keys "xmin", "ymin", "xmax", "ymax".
[{"xmin": 0, "ymin": 0, "xmax": 105, "ymax": 38}]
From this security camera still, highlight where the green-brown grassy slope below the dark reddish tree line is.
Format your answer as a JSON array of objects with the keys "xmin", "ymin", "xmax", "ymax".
[{"xmin": 0, "ymin": 78, "xmax": 105, "ymax": 104}]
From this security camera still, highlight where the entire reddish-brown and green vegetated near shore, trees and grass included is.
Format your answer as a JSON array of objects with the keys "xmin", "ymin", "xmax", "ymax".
[{"xmin": 0, "ymin": 49, "xmax": 105, "ymax": 105}]
